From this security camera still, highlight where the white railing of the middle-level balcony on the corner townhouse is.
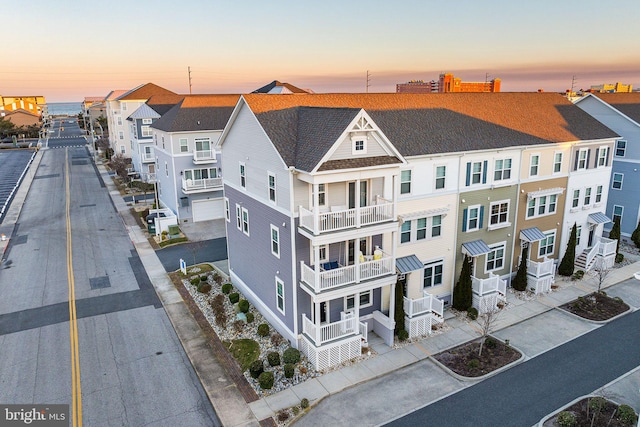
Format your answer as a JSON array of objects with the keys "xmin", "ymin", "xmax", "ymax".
[{"xmin": 300, "ymin": 256, "xmax": 395, "ymax": 293}]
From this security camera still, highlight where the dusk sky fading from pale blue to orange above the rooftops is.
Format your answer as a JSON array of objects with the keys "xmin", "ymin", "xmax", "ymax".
[{"xmin": 0, "ymin": 0, "xmax": 640, "ymax": 102}]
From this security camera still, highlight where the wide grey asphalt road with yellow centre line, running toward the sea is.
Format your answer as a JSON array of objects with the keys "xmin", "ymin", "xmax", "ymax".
[{"xmin": 0, "ymin": 120, "xmax": 219, "ymax": 426}]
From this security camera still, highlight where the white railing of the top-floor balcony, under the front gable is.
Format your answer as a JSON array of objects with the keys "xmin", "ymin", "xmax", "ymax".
[{"xmin": 299, "ymin": 199, "xmax": 393, "ymax": 234}]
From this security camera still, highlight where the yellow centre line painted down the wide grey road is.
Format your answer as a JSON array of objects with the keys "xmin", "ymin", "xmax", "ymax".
[{"xmin": 65, "ymin": 148, "xmax": 82, "ymax": 427}]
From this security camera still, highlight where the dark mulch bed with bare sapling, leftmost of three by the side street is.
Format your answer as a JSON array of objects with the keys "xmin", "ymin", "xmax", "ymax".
[{"xmin": 434, "ymin": 337, "xmax": 522, "ymax": 377}]
